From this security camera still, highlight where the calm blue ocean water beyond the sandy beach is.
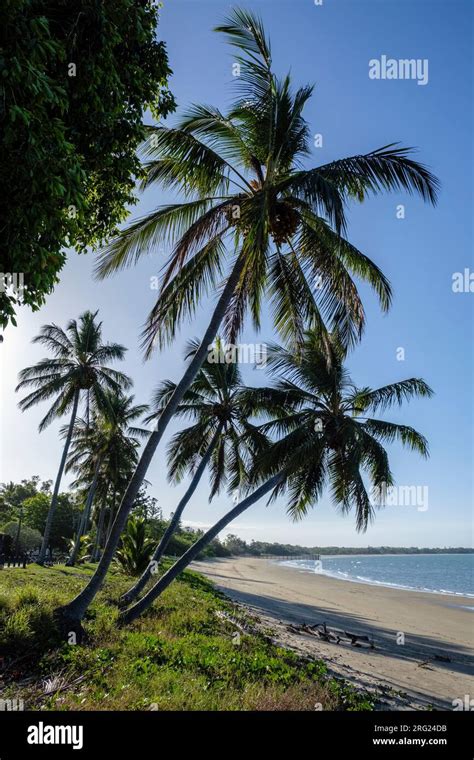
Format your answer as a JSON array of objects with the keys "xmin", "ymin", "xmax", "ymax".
[{"xmin": 283, "ymin": 554, "xmax": 474, "ymax": 610}]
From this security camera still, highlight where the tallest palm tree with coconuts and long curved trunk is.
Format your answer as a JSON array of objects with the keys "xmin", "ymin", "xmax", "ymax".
[{"xmin": 64, "ymin": 10, "xmax": 437, "ymax": 620}]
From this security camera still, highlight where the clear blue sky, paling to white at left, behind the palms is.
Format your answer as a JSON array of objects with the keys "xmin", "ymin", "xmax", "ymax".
[{"xmin": 0, "ymin": 0, "xmax": 474, "ymax": 546}]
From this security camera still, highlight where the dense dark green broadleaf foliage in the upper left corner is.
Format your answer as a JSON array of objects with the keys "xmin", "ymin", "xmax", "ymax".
[{"xmin": 0, "ymin": 0, "xmax": 174, "ymax": 327}]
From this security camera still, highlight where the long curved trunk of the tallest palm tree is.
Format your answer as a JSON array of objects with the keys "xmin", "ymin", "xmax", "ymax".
[{"xmin": 61, "ymin": 256, "xmax": 245, "ymax": 622}]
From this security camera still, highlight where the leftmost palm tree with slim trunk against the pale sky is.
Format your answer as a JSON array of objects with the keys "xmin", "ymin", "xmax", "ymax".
[{"xmin": 16, "ymin": 311, "xmax": 131, "ymax": 564}]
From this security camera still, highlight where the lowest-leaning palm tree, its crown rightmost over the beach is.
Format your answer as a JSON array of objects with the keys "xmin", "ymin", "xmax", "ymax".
[{"xmin": 121, "ymin": 332, "xmax": 432, "ymax": 622}]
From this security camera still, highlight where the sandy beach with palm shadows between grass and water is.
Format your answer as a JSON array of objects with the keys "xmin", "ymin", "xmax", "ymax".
[{"xmin": 195, "ymin": 558, "xmax": 474, "ymax": 709}]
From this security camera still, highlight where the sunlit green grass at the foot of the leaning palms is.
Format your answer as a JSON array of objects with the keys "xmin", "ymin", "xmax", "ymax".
[{"xmin": 0, "ymin": 565, "xmax": 372, "ymax": 710}]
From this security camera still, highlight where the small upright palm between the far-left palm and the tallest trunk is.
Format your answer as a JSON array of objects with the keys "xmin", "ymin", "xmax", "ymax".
[{"xmin": 62, "ymin": 391, "xmax": 148, "ymax": 565}]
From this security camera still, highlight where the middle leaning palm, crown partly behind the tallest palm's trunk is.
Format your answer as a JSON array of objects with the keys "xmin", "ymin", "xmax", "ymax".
[{"xmin": 120, "ymin": 341, "xmax": 267, "ymax": 604}]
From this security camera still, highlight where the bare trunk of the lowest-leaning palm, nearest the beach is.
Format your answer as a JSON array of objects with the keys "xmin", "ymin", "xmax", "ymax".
[{"xmin": 119, "ymin": 473, "xmax": 283, "ymax": 623}]
